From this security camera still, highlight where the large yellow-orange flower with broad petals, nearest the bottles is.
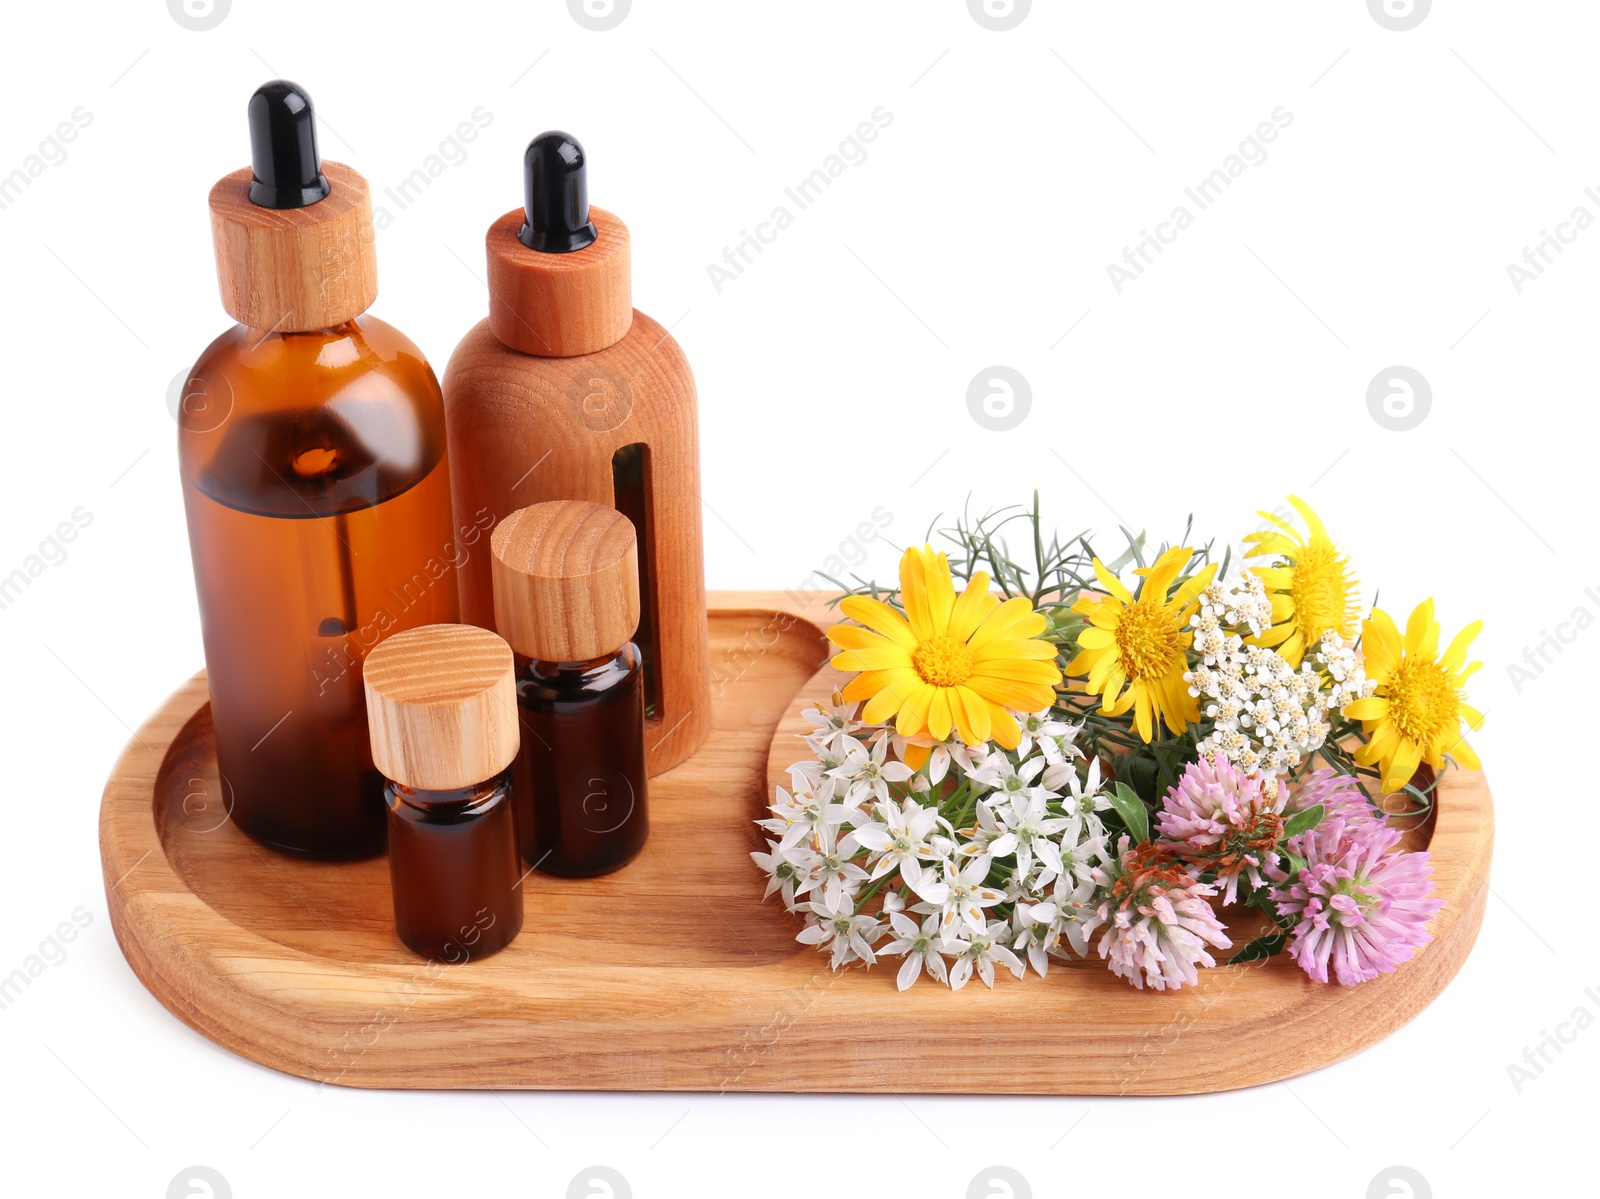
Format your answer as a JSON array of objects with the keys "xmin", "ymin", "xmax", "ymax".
[{"xmin": 827, "ymin": 546, "xmax": 1061, "ymax": 749}]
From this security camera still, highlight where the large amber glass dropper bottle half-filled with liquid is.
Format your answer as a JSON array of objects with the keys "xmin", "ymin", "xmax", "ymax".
[{"xmin": 187, "ymin": 82, "xmax": 459, "ymax": 858}]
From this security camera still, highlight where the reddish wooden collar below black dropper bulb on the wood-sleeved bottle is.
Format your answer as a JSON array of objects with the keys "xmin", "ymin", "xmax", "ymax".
[{"xmin": 480, "ymin": 206, "xmax": 634, "ymax": 359}]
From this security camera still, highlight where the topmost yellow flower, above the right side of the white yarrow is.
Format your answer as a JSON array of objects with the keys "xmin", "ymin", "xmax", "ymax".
[{"xmin": 1245, "ymin": 495, "xmax": 1362, "ymax": 666}]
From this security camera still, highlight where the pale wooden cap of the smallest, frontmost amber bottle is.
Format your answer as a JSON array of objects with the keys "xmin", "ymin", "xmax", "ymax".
[{"xmin": 363, "ymin": 624, "xmax": 520, "ymax": 791}]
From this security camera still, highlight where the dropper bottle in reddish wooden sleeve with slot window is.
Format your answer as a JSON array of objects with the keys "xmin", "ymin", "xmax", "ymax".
[{"xmin": 445, "ymin": 133, "xmax": 710, "ymax": 775}]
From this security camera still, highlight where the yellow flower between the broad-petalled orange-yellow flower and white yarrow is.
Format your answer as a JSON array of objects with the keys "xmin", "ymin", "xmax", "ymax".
[{"xmin": 1067, "ymin": 547, "xmax": 1216, "ymax": 741}]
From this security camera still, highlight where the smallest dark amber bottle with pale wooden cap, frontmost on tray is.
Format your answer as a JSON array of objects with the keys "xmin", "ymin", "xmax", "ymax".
[{"xmin": 363, "ymin": 624, "xmax": 522, "ymax": 964}]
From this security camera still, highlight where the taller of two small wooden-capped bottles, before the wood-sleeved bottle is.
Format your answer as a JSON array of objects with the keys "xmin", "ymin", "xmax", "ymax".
[{"xmin": 491, "ymin": 501, "xmax": 650, "ymax": 877}]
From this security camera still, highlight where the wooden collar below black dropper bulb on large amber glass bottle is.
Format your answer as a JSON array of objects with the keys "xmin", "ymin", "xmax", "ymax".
[{"xmin": 211, "ymin": 162, "xmax": 378, "ymax": 333}]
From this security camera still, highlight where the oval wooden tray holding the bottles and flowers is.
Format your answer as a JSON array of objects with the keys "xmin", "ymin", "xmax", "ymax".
[{"xmin": 101, "ymin": 592, "xmax": 1493, "ymax": 1095}]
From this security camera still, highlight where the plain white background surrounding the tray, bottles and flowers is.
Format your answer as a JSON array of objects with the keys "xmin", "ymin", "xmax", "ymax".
[{"xmin": 0, "ymin": 0, "xmax": 1600, "ymax": 1199}]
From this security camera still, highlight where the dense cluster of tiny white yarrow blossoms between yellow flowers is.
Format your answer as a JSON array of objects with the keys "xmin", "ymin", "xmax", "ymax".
[{"xmin": 1184, "ymin": 571, "xmax": 1374, "ymax": 799}]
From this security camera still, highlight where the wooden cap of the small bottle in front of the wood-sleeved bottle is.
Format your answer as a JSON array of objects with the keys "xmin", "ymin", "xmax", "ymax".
[{"xmin": 490, "ymin": 499, "xmax": 638, "ymax": 663}]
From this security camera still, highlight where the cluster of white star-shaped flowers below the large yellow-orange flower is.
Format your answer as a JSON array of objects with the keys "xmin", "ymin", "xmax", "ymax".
[{"xmin": 750, "ymin": 696, "xmax": 1110, "ymax": 991}]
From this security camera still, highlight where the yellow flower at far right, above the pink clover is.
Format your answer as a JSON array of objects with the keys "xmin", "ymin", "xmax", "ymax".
[{"xmin": 1344, "ymin": 600, "xmax": 1483, "ymax": 791}]
